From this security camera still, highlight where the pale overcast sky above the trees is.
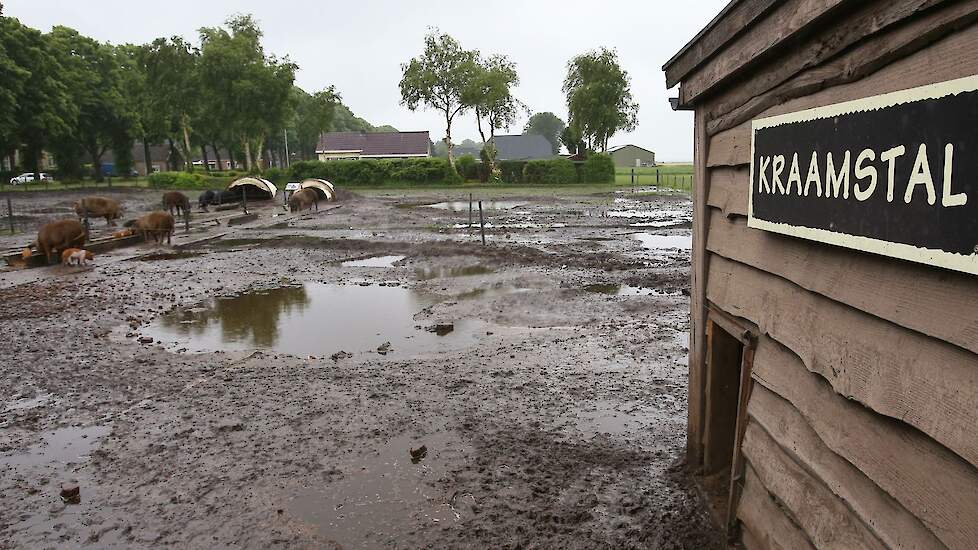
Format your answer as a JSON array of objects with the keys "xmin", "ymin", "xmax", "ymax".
[{"xmin": 3, "ymin": 0, "xmax": 728, "ymax": 161}]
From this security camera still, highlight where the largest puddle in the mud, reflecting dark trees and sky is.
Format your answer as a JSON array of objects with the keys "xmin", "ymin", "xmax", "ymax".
[{"xmin": 143, "ymin": 283, "xmax": 484, "ymax": 355}]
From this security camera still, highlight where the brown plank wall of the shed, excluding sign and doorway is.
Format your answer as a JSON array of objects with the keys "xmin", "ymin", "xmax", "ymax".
[{"xmin": 682, "ymin": 0, "xmax": 978, "ymax": 549}]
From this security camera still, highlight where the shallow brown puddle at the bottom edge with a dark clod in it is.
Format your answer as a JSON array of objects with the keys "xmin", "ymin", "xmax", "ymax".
[{"xmin": 287, "ymin": 431, "xmax": 469, "ymax": 548}]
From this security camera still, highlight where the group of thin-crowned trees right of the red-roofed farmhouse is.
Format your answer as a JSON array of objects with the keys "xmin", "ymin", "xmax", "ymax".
[{"xmin": 400, "ymin": 29, "xmax": 638, "ymax": 179}]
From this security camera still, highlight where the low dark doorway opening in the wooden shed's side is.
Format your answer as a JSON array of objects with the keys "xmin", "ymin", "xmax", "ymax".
[{"xmin": 698, "ymin": 308, "xmax": 754, "ymax": 540}]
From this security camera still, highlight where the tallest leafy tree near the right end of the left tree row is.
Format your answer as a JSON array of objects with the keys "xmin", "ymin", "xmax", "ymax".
[{"xmin": 199, "ymin": 15, "xmax": 296, "ymax": 170}]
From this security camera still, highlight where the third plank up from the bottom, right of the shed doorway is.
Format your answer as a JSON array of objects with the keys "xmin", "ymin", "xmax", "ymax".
[{"xmin": 748, "ymin": 386, "xmax": 944, "ymax": 550}]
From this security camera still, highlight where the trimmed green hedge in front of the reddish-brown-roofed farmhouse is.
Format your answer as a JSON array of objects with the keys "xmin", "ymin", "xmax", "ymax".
[{"xmin": 288, "ymin": 158, "xmax": 462, "ymax": 185}]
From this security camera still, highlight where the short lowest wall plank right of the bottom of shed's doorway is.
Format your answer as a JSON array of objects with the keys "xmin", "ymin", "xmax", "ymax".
[{"xmin": 737, "ymin": 465, "xmax": 815, "ymax": 550}]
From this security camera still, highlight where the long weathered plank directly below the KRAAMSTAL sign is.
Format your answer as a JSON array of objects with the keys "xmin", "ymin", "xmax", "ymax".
[{"xmin": 707, "ymin": 211, "xmax": 978, "ymax": 353}]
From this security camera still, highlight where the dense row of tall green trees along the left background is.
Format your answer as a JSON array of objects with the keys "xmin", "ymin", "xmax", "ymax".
[{"xmin": 0, "ymin": 10, "xmax": 373, "ymax": 180}]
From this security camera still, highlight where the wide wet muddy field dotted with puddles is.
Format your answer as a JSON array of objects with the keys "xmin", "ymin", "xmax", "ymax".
[{"xmin": 0, "ymin": 188, "xmax": 722, "ymax": 548}]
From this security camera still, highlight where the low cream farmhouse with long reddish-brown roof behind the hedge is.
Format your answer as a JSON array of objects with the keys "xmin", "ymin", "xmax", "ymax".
[{"xmin": 316, "ymin": 131, "xmax": 431, "ymax": 161}]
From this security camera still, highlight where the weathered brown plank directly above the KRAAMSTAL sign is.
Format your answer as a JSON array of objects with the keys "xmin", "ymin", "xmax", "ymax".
[{"xmin": 698, "ymin": 14, "xmax": 978, "ymax": 162}]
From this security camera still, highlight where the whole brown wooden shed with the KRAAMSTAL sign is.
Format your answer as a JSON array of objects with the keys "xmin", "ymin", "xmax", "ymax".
[{"xmin": 664, "ymin": 0, "xmax": 978, "ymax": 548}]
